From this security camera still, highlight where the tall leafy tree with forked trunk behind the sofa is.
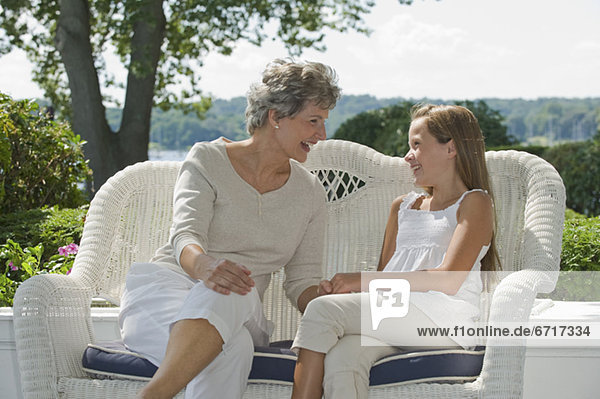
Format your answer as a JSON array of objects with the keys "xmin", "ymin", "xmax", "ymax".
[{"xmin": 0, "ymin": 0, "xmax": 418, "ymax": 194}]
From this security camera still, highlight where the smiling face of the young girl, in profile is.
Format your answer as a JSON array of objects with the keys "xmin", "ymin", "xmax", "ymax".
[{"xmin": 404, "ymin": 118, "xmax": 456, "ymax": 187}]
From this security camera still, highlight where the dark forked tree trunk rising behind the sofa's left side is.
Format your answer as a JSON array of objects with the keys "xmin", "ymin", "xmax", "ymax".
[{"xmin": 55, "ymin": 0, "xmax": 166, "ymax": 192}]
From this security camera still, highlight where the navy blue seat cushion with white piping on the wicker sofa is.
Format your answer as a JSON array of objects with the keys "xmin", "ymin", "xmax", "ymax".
[{"xmin": 82, "ymin": 341, "xmax": 485, "ymax": 386}]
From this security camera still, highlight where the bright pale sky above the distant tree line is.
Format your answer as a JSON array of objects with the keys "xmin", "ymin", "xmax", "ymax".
[{"xmin": 0, "ymin": 0, "xmax": 600, "ymax": 100}]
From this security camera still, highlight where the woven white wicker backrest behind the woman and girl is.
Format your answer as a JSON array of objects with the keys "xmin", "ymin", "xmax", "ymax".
[{"xmin": 73, "ymin": 140, "xmax": 564, "ymax": 340}]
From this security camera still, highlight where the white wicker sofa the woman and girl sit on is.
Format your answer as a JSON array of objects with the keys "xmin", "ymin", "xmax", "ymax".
[{"xmin": 14, "ymin": 140, "xmax": 565, "ymax": 399}]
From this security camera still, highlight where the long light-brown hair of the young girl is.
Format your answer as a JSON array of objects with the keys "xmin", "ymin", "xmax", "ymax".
[{"xmin": 411, "ymin": 104, "xmax": 500, "ymax": 271}]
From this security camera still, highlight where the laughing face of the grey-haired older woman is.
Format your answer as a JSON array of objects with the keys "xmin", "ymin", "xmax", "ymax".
[{"xmin": 275, "ymin": 103, "xmax": 329, "ymax": 162}]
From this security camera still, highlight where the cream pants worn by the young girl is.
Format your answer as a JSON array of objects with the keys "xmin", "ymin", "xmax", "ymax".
[{"xmin": 292, "ymin": 293, "xmax": 457, "ymax": 399}]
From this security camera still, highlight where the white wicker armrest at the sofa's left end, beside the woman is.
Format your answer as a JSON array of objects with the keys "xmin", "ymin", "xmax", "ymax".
[{"xmin": 13, "ymin": 274, "xmax": 93, "ymax": 398}]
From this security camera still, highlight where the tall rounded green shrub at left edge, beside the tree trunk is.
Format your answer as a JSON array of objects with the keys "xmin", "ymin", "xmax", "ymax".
[{"xmin": 0, "ymin": 93, "xmax": 91, "ymax": 213}]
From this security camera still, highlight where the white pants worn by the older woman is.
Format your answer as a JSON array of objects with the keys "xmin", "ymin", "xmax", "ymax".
[{"xmin": 119, "ymin": 263, "xmax": 270, "ymax": 399}]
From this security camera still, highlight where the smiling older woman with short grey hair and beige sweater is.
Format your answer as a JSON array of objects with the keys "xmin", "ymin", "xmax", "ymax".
[{"xmin": 120, "ymin": 60, "xmax": 340, "ymax": 398}]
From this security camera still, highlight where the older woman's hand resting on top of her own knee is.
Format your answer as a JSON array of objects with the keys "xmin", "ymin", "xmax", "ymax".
[{"xmin": 198, "ymin": 257, "xmax": 254, "ymax": 295}]
